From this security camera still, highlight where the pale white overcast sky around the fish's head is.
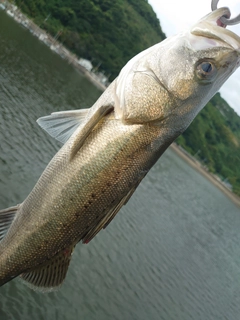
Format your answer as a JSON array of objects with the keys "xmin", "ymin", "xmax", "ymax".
[{"xmin": 148, "ymin": 0, "xmax": 240, "ymax": 116}]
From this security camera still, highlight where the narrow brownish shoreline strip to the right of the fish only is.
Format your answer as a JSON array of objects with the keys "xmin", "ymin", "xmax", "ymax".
[{"xmin": 170, "ymin": 142, "xmax": 240, "ymax": 208}]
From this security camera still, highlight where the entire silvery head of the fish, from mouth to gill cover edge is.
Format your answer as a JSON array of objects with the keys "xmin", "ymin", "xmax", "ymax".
[{"xmin": 115, "ymin": 8, "xmax": 240, "ymax": 131}]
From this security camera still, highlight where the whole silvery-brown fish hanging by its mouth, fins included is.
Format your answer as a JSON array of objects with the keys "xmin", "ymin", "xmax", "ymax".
[{"xmin": 0, "ymin": 8, "xmax": 240, "ymax": 291}]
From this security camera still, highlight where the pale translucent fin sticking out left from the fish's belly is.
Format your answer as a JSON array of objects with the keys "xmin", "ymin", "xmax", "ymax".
[{"xmin": 37, "ymin": 109, "xmax": 89, "ymax": 143}]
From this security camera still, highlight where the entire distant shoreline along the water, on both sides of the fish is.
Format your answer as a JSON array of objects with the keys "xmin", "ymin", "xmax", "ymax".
[{"xmin": 0, "ymin": 0, "xmax": 240, "ymax": 207}]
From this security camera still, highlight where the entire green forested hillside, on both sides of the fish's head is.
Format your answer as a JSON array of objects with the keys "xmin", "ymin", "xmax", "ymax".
[{"xmin": 12, "ymin": 0, "xmax": 240, "ymax": 195}]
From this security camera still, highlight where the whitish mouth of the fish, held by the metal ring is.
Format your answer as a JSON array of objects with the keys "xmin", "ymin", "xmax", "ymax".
[{"xmin": 190, "ymin": 7, "xmax": 240, "ymax": 53}]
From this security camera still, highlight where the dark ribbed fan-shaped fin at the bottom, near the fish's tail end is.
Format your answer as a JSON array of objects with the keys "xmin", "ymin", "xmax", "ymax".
[{"xmin": 20, "ymin": 245, "xmax": 74, "ymax": 292}]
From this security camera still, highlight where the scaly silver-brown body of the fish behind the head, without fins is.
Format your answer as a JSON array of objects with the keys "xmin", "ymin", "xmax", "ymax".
[{"xmin": 0, "ymin": 98, "xmax": 179, "ymax": 284}]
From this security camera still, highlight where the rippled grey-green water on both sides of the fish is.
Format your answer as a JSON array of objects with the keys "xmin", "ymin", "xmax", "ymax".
[{"xmin": 0, "ymin": 11, "xmax": 240, "ymax": 320}]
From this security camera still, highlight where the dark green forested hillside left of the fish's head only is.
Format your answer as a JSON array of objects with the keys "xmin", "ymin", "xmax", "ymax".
[{"xmin": 15, "ymin": 0, "xmax": 165, "ymax": 80}]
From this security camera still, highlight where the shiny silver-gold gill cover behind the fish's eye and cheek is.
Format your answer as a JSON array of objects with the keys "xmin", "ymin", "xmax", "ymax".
[{"xmin": 115, "ymin": 42, "xmax": 175, "ymax": 123}]
